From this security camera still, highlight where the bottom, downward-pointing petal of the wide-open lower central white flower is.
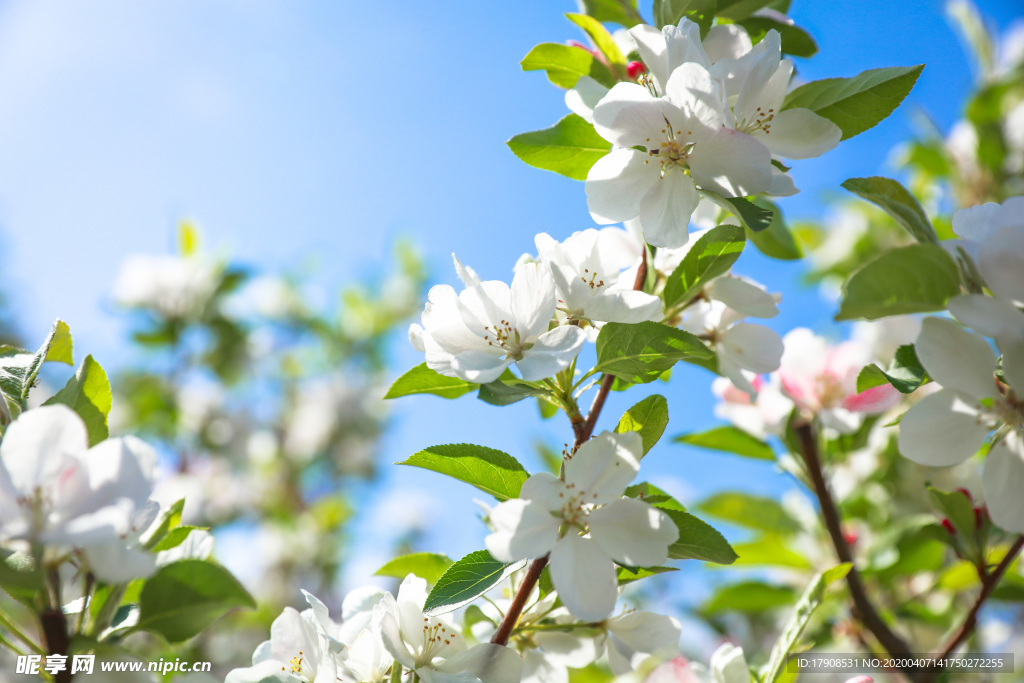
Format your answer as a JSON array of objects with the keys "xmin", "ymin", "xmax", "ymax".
[{"xmin": 549, "ymin": 533, "xmax": 618, "ymax": 622}]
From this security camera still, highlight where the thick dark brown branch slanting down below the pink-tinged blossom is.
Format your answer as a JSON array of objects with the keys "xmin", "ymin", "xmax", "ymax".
[{"xmin": 794, "ymin": 422, "xmax": 913, "ymax": 679}]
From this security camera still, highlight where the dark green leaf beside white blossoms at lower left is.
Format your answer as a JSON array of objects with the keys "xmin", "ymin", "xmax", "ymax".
[{"xmin": 135, "ymin": 560, "xmax": 256, "ymax": 643}]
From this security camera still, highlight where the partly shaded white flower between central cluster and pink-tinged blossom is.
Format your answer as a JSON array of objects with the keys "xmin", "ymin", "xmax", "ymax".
[{"xmin": 681, "ymin": 275, "xmax": 782, "ymax": 394}]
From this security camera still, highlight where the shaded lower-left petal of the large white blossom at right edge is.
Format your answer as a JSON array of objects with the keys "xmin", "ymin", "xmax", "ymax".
[{"xmin": 899, "ymin": 389, "xmax": 990, "ymax": 467}]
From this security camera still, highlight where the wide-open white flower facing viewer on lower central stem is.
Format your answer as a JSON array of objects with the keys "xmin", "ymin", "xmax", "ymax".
[{"xmin": 486, "ymin": 432, "xmax": 679, "ymax": 622}]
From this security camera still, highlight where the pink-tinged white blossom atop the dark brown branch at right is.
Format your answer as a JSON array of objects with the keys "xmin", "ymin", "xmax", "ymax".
[{"xmin": 778, "ymin": 328, "xmax": 900, "ymax": 433}]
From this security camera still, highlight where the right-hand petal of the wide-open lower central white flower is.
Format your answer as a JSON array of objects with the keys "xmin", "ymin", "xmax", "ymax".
[{"xmin": 588, "ymin": 498, "xmax": 679, "ymax": 566}]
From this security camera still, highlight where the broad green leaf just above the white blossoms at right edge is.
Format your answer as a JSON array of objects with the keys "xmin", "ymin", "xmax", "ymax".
[{"xmin": 836, "ymin": 245, "xmax": 959, "ymax": 321}]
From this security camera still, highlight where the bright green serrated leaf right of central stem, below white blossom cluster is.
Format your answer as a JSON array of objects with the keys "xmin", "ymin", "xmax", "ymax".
[{"xmin": 594, "ymin": 322, "xmax": 714, "ymax": 384}]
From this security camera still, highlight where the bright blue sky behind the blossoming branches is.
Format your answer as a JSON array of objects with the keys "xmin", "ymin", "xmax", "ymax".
[{"xmin": 0, "ymin": 0, "xmax": 1020, "ymax": 614}]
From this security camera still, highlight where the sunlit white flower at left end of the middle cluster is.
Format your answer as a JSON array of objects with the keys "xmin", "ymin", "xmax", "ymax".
[{"xmin": 410, "ymin": 261, "xmax": 586, "ymax": 384}]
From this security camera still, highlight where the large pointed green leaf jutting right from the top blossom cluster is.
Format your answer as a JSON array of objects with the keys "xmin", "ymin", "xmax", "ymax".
[{"xmin": 782, "ymin": 65, "xmax": 925, "ymax": 140}]
